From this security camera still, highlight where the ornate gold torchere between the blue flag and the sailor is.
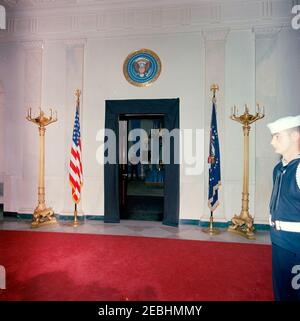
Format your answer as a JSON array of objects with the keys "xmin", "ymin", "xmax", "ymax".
[{"xmin": 228, "ymin": 104, "xmax": 264, "ymax": 239}]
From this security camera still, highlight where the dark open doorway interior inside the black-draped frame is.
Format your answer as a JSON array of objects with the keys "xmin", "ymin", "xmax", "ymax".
[{"xmin": 119, "ymin": 114, "xmax": 165, "ymax": 221}]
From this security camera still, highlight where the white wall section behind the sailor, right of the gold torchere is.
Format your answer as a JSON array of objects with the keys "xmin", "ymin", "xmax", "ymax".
[{"xmin": 255, "ymin": 28, "xmax": 300, "ymax": 222}]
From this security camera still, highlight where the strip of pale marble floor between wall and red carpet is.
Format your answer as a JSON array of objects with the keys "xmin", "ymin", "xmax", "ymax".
[{"xmin": 0, "ymin": 217, "xmax": 270, "ymax": 244}]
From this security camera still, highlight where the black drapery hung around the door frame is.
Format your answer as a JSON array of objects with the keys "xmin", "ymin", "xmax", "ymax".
[{"xmin": 104, "ymin": 98, "xmax": 179, "ymax": 226}]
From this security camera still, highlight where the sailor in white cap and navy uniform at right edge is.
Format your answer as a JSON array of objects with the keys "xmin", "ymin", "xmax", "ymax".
[{"xmin": 268, "ymin": 115, "xmax": 300, "ymax": 301}]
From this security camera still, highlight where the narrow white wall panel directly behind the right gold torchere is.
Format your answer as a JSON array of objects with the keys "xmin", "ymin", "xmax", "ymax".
[{"xmin": 223, "ymin": 30, "xmax": 256, "ymax": 219}]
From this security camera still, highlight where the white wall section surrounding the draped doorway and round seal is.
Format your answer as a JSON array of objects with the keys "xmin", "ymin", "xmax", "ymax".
[{"xmin": 82, "ymin": 35, "xmax": 204, "ymax": 219}]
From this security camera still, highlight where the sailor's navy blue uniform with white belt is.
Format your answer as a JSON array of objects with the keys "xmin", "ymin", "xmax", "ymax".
[{"xmin": 270, "ymin": 158, "xmax": 300, "ymax": 300}]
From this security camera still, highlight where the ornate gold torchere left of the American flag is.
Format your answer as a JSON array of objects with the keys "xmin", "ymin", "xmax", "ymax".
[{"xmin": 26, "ymin": 108, "xmax": 57, "ymax": 227}]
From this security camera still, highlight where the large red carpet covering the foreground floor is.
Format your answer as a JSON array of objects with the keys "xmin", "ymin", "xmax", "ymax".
[{"xmin": 0, "ymin": 231, "xmax": 273, "ymax": 301}]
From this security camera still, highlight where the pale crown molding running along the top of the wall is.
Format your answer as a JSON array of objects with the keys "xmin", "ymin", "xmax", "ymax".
[{"xmin": 0, "ymin": 0, "xmax": 295, "ymax": 42}]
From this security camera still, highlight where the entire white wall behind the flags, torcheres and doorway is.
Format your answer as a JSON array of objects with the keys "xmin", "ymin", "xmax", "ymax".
[{"xmin": 0, "ymin": 1, "xmax": 300, "ymax": 223}]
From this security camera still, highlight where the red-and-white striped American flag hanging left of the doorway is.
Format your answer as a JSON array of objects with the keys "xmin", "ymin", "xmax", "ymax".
[{"xmin": 69, "ymin": 102, "xmax": 83, "ymax": 204}]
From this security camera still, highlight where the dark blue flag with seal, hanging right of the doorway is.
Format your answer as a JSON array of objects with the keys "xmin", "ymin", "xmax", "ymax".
[{"xmin": 208, "ymin": 98, "xmax": 221, "ymax": 212}]
